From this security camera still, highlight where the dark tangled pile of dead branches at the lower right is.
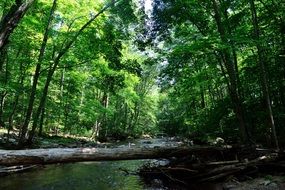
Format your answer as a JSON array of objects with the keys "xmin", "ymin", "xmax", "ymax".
[{"xmin": 139, "ymin": 148, "xmax": 285, "ymax": 186}]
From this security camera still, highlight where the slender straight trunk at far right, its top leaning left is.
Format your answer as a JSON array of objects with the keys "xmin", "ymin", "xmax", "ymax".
[{"xmin": 249, "ymin": 0, "xmax": 279, "ymax": 149}]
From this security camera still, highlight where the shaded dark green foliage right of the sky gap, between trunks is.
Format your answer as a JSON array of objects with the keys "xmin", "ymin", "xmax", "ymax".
[{"xmin": 154, "ymin": 0, "xmax": 284, "ymax": 145}]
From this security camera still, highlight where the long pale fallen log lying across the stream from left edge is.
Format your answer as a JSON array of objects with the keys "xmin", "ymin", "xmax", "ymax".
[{"xmin": 0, "ymin": 146, "xmax": 221, "ymax": 166}]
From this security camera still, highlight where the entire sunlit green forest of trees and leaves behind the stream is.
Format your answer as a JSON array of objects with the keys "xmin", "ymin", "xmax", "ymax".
[{"xmin": 0, "ymin": 0, "xmax": 285, "ymax": 148}]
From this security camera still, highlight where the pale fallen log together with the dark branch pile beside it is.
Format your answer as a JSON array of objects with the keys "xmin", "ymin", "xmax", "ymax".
[{"xmin": 0, "ymin": 146, "xmax": 285, "ymax": 182}]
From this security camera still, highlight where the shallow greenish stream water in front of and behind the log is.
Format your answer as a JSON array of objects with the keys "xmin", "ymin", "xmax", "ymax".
[{"xmin": 0, "ymin": 139, "xmax": 220, "ymax": 190}]
